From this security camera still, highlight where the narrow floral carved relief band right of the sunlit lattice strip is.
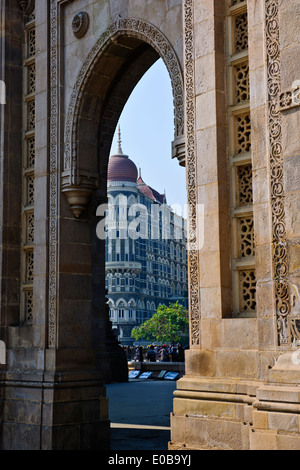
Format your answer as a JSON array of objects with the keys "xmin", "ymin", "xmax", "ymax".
[{"xmin": 266, "ymin": 0, "xmax": 291, "ymax": 346}]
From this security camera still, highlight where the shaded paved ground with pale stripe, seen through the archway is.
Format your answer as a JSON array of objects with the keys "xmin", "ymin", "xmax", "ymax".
[{"xmin": 106, "ymin": 380, "xmax": 176, "ymax": 450}]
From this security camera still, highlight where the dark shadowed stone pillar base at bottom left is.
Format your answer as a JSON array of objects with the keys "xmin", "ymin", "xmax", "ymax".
[{"xmin": 0, "ymin": 372, "xmax": 110, "ymax": 450}]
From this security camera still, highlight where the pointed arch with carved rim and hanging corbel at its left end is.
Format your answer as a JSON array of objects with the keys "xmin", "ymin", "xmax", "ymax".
[{"xmin": 62, "ymin": 18, "xmax": 185, "ymax": 217}]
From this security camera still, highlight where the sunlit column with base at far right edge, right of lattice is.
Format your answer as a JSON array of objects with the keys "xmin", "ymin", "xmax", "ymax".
[{"xmin": 250, "ymin": 0, "xmax": 300, "ymax": 450}]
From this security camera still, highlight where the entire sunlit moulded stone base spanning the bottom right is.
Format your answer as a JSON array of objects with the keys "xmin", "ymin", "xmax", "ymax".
[{"xmin": 169, "ymin": 353, "xmax": 300, "ymax": 450}]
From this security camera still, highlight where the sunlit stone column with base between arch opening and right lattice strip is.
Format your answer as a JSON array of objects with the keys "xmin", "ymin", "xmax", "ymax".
[{"xmin": 170, "ymin": 0, "xmax": 264, "ymax": 449}]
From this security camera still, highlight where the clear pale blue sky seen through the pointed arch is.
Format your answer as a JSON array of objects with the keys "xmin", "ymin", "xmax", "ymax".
[{"xmin": 111, "ymin": 59, "xmax": 187, "ymax": 211}]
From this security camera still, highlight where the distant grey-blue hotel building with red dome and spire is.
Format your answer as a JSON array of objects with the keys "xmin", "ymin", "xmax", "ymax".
[{"xmin": 106, "ymin": 134, "xmax": 188, "ymax": 345}]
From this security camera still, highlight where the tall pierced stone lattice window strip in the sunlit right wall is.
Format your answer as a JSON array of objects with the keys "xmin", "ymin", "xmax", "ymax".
[{"xmin": 227, "ymin": 0, "xmax": 256, "ymax": 316}]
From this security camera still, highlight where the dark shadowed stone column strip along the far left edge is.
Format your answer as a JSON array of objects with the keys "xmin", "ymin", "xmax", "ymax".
[{"xmin": 0, "ymin": 1, "xmax": 23, "ymax": 360}]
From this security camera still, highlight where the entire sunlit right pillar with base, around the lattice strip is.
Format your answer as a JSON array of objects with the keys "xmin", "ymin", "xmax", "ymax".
[{"xmin": 170, "ymin": 0, "xmax": 300, "ymax": 450}]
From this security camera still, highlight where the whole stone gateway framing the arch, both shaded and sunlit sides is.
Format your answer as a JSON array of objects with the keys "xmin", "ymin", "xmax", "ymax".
[{"xmin": 0, "ymin": 0, "xmax": 300, "ymax": 450}]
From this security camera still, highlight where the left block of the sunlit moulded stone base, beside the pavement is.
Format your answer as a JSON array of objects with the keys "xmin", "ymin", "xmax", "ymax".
[{"xmin": 169, "ymin": 376, "xmax": 259, "ymax": 450}]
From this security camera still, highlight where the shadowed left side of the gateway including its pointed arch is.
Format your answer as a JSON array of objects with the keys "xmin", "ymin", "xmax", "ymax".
[{"xmin": 0, "ymin": 0, "xmax": 188, "ymax": 450}]
